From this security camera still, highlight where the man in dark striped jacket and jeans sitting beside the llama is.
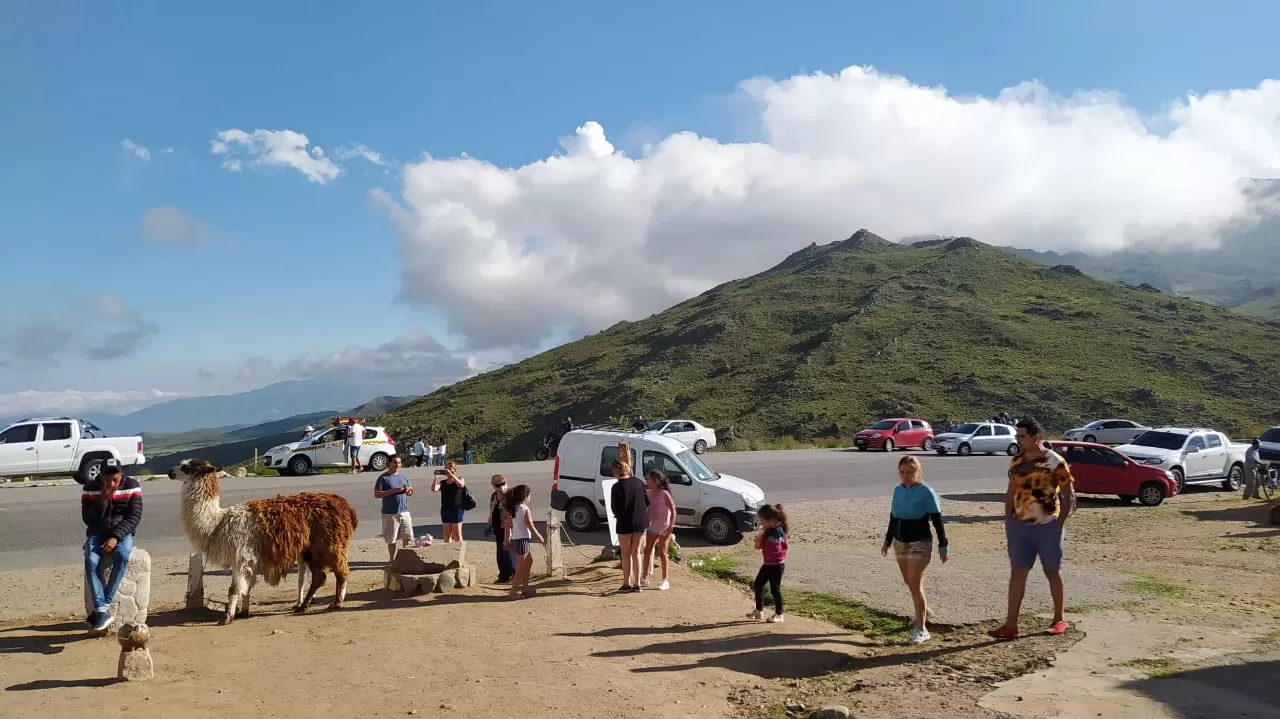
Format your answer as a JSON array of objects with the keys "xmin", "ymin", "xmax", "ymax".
[{"xmin": 81, "ymin": 459, "xmax": 142, "ymax": 631}]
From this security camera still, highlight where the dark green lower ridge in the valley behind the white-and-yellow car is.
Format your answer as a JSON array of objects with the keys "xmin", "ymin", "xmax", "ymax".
[{"xmin": 142, "ymin": 397, "xmax": 417, "ymax": 472}]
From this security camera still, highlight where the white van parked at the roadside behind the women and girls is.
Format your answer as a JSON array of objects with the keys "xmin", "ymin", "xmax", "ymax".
[{"xmin": 552, "ymin": 430, "xmax": 764, "ymax": 545}]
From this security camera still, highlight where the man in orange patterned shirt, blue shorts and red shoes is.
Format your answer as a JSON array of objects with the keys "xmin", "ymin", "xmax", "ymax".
[{"xmin": 987, "ymin": 417, "xmax": 1075, "ymax": 640}]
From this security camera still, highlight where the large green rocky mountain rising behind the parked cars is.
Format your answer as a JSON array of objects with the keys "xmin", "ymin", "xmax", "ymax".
[{"xmin": 380, "ymin": 230, "xmax": 1280, "ymax": 461}]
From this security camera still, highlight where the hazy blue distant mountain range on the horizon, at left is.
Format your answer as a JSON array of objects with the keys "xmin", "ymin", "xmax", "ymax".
[{"xmin": 0, "ymin": 376, "xmax": 424, "ymax": 436}]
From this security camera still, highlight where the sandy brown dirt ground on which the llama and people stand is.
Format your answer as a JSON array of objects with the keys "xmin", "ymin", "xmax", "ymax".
[{"xmin": 0, "ymin": 493, "xmax": 1280, "ymax": 719}]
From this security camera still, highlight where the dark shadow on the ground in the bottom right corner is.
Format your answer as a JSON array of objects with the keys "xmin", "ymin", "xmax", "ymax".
[{"xmin": 1125, "ymin": 659, "xmax": 1280, "ymax": 719}]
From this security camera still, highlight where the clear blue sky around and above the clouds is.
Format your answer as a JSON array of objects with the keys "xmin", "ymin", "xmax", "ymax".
[{"xmin": 0, "ymin": 0, "xmax": 1280, "ymax": 414}]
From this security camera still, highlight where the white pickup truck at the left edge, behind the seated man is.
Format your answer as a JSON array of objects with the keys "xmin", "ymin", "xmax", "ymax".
[{"xmin": 0, "ymin": 417, "xmax": 147, "ymax": 484}]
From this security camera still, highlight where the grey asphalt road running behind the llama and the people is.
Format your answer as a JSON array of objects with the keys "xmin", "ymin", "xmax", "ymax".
[{"xmin": 0, "ymin": 449, "xmax": 1009, "ymax": 571}]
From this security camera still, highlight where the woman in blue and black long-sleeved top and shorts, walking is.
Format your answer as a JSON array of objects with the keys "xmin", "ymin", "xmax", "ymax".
[{"xmin": 881, "ymin": 457, "xmax": 947, "ymax": 644}]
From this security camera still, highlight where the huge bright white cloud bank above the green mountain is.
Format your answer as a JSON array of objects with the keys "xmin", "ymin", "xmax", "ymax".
[{"xmin": 374, "ymin": 68, "xmax": 1280, "ymax": 348}]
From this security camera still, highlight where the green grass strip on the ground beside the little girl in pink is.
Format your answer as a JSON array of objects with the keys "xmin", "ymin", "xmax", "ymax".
[{"xmin": 689, "ymin": 557, "xmax": 911, "ymax": 640}]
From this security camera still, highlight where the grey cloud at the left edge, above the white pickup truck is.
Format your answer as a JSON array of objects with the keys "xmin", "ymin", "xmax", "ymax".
[{"xmin": 0, "ymin": 293, "xmax": 159, "ymax": 371}]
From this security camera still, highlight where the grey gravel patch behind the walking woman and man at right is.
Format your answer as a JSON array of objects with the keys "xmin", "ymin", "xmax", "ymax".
[{"xmin": 695, "ymin": 494, "xmax": 1132, "ymax": 624}]
